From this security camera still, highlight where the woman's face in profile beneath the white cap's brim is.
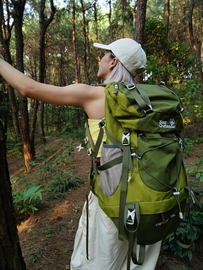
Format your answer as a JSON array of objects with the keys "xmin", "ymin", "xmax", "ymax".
[{"xmin": 97, "ymin": 51, "xmax": 115, "ymax": 80}]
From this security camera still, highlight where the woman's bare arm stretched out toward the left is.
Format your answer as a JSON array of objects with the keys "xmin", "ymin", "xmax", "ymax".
[{"xmin": 0, "ymin": 58, "xmax": 104, "ymax": 117}]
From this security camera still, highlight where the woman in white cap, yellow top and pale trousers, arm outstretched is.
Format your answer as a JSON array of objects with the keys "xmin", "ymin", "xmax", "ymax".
[{"xmin": 0, "ymin": 38, "xmax": 161, "ymax": 270}]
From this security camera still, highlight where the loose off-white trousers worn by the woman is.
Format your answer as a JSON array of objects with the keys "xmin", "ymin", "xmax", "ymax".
[{"xmin": 70, "ymin": 192, "xmax": 161, "ymax": 270}]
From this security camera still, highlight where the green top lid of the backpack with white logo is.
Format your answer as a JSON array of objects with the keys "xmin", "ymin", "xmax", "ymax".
[{"xmin": 105, "ymin": 82, "xmax": 183, "ymax": 133}]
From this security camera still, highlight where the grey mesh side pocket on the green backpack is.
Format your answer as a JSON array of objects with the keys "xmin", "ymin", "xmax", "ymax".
[{"xmin": 99, "ymin": 144, "xmax": 122, "ymax": 196}]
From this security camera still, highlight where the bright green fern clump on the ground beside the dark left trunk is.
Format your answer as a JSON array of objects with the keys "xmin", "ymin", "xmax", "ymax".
[{"xmin": 13, "ymin": 186, "xmax": 43, "ymax": 214}]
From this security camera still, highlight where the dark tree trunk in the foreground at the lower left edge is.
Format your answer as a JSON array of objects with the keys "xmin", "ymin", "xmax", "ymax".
[{"xmin": 0, "ymin": 121, "xmax": 26, "ymax": 270}]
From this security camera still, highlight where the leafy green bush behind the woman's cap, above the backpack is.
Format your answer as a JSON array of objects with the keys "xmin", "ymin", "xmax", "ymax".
[{"xmin": 144, "ymin": 17, "xmax": 194, "ymax": 85}]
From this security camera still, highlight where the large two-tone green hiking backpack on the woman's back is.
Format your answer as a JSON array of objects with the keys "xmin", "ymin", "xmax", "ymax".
[{"xmin": 83, "ymin": 82, "xmax": 192, "ymax": 269}]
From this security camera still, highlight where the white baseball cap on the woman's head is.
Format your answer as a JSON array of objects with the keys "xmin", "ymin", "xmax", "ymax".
[{"xmin": 93, "ymin": 38, "xmax": 147, "ymax": 76}]
